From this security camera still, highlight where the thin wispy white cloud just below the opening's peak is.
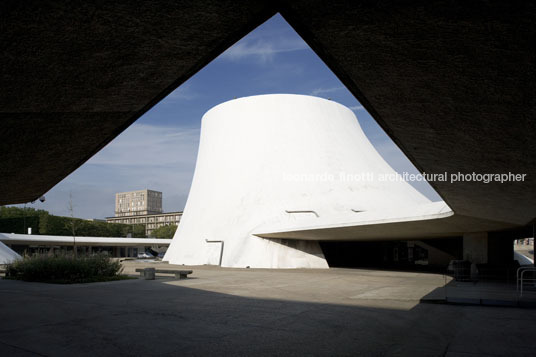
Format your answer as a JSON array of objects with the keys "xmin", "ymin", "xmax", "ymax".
[{"xmin": 221, "ymin": 38, "xmax": 309, "ymax": 63}]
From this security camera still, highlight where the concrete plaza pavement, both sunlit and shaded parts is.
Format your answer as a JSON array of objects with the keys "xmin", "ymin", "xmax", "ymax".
[{"xmin": 0, "ymin": 261, "xmax": 536, "ymax": 356}]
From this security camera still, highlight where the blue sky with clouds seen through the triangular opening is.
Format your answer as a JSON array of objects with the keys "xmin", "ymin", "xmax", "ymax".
[{"xmin": 30, "ymin": 15, "xmax": 440, "ymax": 218}]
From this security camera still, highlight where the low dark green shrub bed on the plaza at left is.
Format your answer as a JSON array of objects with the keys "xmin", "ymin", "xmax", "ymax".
[{"xmin": 5, "ymin": 254, "xmax": 130, "ymax": 284}]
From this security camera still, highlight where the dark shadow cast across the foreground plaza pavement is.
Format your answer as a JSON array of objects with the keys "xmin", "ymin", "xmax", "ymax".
[{"xmin": 0, "ymin": 280, "xmax": 536, "ymax": 356}]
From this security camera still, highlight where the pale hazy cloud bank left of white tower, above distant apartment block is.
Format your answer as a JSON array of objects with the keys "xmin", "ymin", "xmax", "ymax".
[{"xmin": 38, "ymin": 124, "xmax": 199, "ymax": 218}]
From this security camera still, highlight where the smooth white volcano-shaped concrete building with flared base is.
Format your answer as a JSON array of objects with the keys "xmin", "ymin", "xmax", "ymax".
[{"xmin": 164, "ymin": 94, "xmax": 429, "ymax": 268}]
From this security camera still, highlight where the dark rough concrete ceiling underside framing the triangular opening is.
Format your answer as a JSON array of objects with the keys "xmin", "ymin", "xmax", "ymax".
[{"xmin": 0, "ymin": 0, "xmax": 536, "ymax": 227}]
